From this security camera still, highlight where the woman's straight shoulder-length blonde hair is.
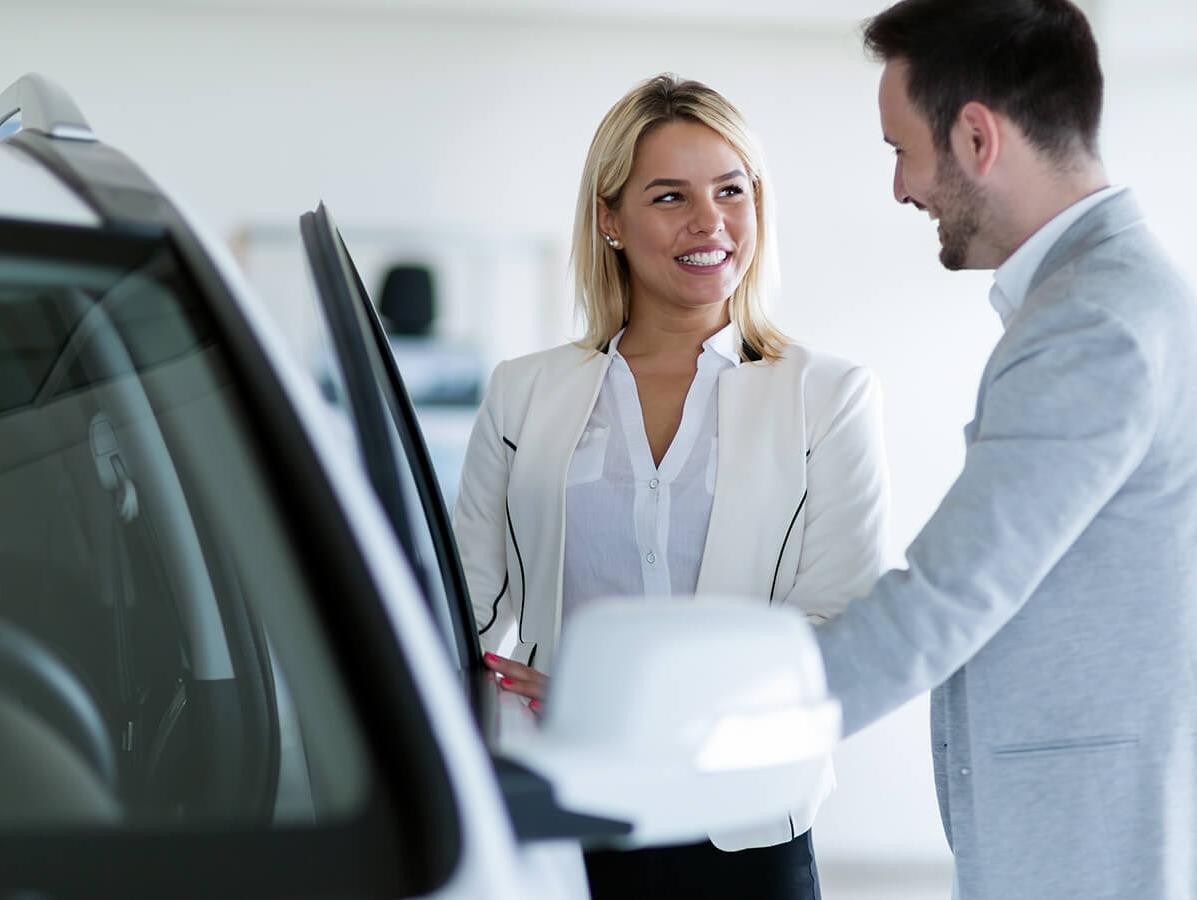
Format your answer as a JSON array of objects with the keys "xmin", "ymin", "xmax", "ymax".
[{"xmin": 571, "ymin": 74, "xmax": 786, "ymax": 360}]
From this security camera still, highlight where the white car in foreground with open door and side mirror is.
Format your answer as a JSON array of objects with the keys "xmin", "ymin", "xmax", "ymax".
[{"xmin": 0, "ymin": 75, "xmax": 838, "ymax": 900}]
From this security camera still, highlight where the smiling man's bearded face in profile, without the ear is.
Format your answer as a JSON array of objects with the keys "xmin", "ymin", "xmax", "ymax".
[{"xmin": 879, "ymin": 60, "xmax": 985, "ymax": 270}]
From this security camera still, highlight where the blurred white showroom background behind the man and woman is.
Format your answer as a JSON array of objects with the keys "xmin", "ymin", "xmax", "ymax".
[{"xmin": 0, "ymin": 0, "xmax": 1197, "ymax": 900}]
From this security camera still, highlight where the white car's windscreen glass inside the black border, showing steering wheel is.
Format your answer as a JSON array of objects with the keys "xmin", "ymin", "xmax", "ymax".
[{"xmin": 0, "ymin": 220, "xmax": 371, "ymax": 831}]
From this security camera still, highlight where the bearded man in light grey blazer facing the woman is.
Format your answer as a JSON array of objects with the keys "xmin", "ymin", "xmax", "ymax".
[{"xmin": 818, "ymin": 0, "xmax": 1197, "ymax": 900}]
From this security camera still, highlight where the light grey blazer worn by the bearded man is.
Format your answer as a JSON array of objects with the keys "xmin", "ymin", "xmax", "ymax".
[{"xmin": 819, "ymin": 193, "xmax": 1197, "ymax": 900}]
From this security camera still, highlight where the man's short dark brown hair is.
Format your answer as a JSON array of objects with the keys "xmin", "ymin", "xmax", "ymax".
[{"xmin": 864, "ymin": 0, "xmax": 1102, "ymax": 162}]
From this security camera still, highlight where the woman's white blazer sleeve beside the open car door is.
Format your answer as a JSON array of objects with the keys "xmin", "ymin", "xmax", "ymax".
[{"xmin": 452, "ymin": 363, "xmax": 516, "ymax": 650}]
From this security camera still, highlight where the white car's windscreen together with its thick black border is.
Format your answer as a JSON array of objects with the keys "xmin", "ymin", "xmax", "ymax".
[{"xmin": 0, "ymin": 210, "xmax": 461, "ymax": 896}]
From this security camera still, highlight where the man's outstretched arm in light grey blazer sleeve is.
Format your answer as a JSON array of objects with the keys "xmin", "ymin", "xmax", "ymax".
[{"xmin": 816, "ymin": 304, "xmax": 1156, "ymax": 735}]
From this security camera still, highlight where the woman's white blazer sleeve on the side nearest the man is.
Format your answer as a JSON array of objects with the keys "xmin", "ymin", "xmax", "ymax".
[{"xmin": 785, "ymin": 367, "xmax": 889, "ymax": 622}]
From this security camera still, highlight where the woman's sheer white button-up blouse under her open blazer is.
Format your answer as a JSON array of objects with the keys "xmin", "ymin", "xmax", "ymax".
[{"xmin": 561, "ymin": 324, "xmax": 740, "ymax": 624}]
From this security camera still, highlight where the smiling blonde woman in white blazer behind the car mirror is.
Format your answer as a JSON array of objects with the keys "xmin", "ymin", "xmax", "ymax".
[{"xmin": 454, "ymin": 75, "xmax": 886, "ymax": 900}]
